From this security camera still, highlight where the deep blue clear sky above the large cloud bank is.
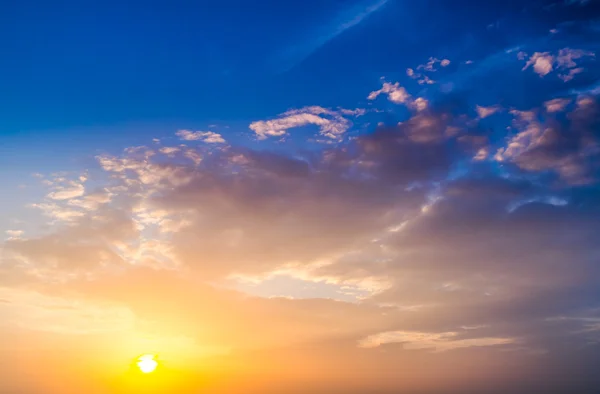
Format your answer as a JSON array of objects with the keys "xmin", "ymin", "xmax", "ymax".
[{"xmin": 0, "ymin": 0, "xmax": 598, "ymax": 172}]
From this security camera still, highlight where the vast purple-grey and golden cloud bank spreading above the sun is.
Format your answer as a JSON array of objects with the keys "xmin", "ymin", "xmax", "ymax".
[{"xmin": 5, "ymin": 72, "xmax": 600, "ymax": 392}]
